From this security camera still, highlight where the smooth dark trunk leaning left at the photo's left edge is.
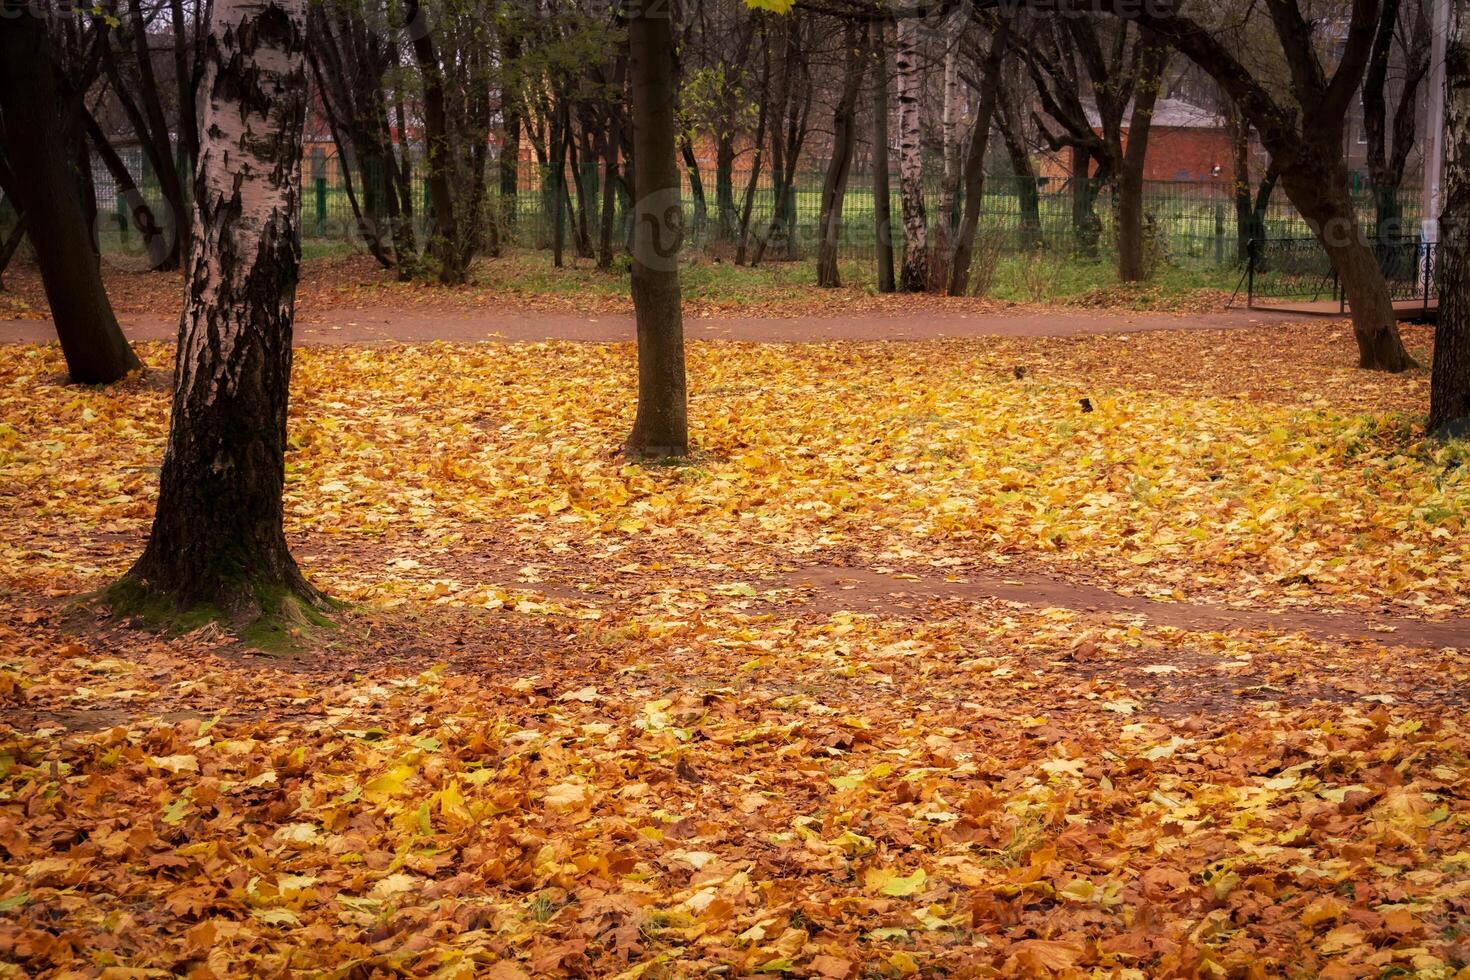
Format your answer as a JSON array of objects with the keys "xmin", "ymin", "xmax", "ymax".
[{"xmin": 0, "ymin": 0, "xmax": 141, "ymax": 385}]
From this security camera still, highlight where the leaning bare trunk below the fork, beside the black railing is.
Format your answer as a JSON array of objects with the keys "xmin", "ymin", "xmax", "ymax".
[{"xmin": 1280, "ymin": 159, "xmax": 1414, "ymax": 372}]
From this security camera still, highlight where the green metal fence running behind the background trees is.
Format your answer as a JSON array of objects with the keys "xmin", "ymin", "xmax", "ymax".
[{"xmin": 77, "ymin": 143, "xmax": 1420, "ymax": 269}]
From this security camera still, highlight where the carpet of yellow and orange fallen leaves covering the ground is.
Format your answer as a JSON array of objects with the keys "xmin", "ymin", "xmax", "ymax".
[{"xmin": 0, "ymin": 326, "xmax": 1470, "ymax": 979}]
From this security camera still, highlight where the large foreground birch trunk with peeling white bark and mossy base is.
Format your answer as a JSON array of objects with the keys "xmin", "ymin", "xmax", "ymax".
[{"xmin": 113, "ymin": 0, "xmax": 325, "ymax": 639}]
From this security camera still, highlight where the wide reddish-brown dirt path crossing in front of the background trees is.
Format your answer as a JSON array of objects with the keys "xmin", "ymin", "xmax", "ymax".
[{"xmin": 0, "ymin": 307, "xmax": 1291, "ymax": 344}]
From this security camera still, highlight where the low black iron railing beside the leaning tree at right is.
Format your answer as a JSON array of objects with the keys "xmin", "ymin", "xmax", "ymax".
[{"xmin": 1247, "ymin": 238, "xmax": 1439, "ymax": 313}]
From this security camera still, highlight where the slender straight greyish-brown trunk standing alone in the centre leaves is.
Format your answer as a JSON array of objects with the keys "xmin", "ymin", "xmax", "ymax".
[{"xmin": 626, "ymin": 4, "xmax": 689, "ymax": 458}]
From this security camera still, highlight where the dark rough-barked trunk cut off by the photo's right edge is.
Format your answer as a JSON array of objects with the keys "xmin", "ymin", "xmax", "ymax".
[{"xmin": 1429, "ymin": 0, "xmax": 1470, "ymax": 438}]
